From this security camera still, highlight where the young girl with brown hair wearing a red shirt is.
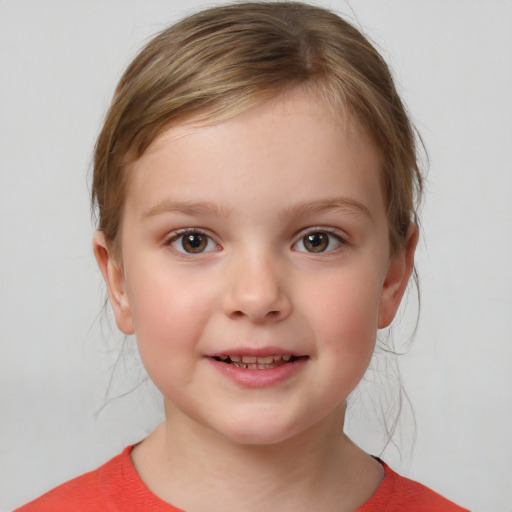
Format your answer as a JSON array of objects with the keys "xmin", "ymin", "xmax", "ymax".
[{"xmin": 14, "ymin": 2, "xmax": 470, "ymax": 512}]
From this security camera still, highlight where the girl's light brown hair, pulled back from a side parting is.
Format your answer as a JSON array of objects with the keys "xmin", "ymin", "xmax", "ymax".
[{"xmin": 92, "ymin": 2, "xmax": 422, "ymax": 254}]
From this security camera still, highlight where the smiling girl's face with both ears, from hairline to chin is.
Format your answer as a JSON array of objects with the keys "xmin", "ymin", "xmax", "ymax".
[{"xmin": 95, "ymin": 92, "xmax": 414, "ymax": 444}]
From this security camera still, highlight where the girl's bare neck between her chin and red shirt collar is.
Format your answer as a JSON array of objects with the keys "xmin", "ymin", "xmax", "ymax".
[{"xmin": 132, "ymin": 405, "xmax": 382, "ymax": 512}]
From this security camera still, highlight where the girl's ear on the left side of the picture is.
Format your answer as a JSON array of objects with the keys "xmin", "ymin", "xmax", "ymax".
[{"xmin": 92, "ymin": 231, "xmax": 134, "ymax": 334}]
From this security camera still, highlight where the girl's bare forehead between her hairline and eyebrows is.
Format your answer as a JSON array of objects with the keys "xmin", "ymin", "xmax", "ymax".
[{"xmin": 123, "ymin": 90, "xmax": 382, "ymax": 222}]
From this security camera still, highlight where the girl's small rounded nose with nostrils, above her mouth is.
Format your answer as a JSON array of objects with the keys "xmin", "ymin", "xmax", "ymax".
[{"xmin": 223, "ymin": 252, "xmax": 292, "ymax": 323}]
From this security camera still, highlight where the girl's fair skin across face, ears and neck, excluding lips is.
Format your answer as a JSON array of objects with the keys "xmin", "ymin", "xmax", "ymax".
[{"xmin": 94, "ymin": 90, "xmax": 417, "ymax": 512}]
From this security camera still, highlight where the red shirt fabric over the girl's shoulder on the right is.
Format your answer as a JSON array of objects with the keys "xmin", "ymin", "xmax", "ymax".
[{"xmin": 358, "ymin": 463, "xmax": 469, "ymax": 512}]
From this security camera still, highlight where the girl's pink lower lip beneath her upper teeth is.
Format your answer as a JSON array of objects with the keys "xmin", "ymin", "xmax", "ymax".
[{"xmin": 208, "ymin": 357, "xmax": 308, "ymax": 388}]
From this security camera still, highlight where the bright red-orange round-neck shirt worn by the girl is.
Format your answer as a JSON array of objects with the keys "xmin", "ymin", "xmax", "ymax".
[{"xmin": 14, "ymin": 446, "xmax": 468, "ymax": 512}]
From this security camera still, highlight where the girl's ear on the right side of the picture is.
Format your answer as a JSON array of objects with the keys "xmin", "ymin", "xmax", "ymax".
[{"xmin": 378, "ymin": 222, "xmax": 419, "ymax": 329}]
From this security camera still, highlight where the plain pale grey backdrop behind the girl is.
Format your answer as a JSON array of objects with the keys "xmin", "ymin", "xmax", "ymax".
[{"xmin": 0, "ymin": 0, "xmax": 512, "ymax": 512}]
